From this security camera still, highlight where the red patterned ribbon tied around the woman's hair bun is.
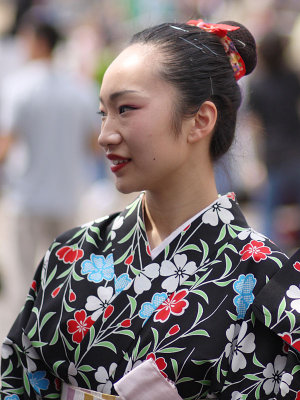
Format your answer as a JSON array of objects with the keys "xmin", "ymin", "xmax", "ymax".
[{"xmin": 187, "ymin": 19, "xmax": 246, "ymax": 80}]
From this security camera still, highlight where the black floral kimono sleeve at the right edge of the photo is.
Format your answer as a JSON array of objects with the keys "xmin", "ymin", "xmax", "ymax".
[{"xmin": 220, "ymin": 251, "xmax": 300, "ymax": 400}]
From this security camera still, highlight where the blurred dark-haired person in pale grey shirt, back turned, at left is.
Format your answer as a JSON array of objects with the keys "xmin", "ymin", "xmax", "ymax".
[{"xmin": 0, "ymin": 14, "xmax": 97, "ymax": 283}]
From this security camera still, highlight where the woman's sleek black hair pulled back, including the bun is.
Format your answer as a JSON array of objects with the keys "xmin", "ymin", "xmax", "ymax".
[{"xmin": 130, "ymin": 21, "xmax": 256, "ymax": 161}]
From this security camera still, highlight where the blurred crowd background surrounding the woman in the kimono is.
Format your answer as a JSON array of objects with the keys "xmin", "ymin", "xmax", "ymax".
[{"xmin": 0, "ymin": 0, "xmax": 300, "ymax": 342}]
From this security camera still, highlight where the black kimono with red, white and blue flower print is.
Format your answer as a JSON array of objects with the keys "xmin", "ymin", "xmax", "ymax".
[{"xmin": 1, "ymin": 193, "xmax": 300, "ymax": 400}]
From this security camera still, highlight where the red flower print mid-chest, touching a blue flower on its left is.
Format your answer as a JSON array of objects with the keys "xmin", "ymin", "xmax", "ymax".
[{"xmin": 154, "ymin": 289, "xmax": 189, "ymax": 322}]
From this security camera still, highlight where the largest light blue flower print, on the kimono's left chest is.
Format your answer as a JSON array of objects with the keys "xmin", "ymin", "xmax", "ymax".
[{"xmin": 81, "ymin": 254, "xmax": 115, "ymax": 283}]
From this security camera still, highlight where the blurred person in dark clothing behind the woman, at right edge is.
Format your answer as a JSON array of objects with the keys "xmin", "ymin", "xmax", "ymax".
[{"xmin": 249, "ymin": 31, "xmax": 300, "ymax": 250}]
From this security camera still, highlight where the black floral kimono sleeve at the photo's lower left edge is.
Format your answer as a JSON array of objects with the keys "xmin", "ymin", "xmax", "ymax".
[{"xmin": 0, "ymin": 252, "xmax": 60, "ymax": 400}]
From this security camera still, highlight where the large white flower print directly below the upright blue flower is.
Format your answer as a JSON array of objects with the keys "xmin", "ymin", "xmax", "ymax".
[{"xmin": 225, "ymin": 321, "xmax": 255, "ymax": 372}]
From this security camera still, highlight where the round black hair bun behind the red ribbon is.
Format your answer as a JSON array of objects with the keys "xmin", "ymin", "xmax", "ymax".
[{"xmin": 219, "ymin": 21, "xmax": 257, "ymax": 75}]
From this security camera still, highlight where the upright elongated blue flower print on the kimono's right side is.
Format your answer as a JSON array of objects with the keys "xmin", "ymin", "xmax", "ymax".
[{"xmin": 233, "ymin": 274, "xmax": 256, "ymax": 319}]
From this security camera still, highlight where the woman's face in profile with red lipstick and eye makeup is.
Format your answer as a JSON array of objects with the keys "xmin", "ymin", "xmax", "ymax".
[{"xmin": 99, "ymin": 44, "xmax": 190, "ymax": 193}]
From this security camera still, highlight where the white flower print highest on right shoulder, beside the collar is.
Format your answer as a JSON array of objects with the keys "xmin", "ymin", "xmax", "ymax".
[{"xmin": 202, "ymin": 196, "xmax": 234, "ymax": 226}]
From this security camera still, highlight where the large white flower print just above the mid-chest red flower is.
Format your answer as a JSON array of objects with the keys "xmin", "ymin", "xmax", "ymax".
[{"xmin": 160, "ymin": 254, "xmax": 197, "ymax": 293}]
